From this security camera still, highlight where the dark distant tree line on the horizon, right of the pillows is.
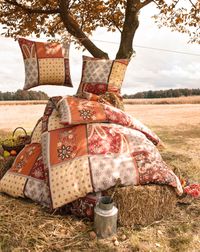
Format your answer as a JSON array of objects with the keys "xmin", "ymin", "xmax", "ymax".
[{"xmin": 123, "ymin": 88, "xmax": 200, "ymax": 99}]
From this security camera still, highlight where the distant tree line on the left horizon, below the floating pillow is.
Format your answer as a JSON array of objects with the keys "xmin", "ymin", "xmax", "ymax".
[{"xmin": 0, "ymin": 89, "xmax": 49, "ymax": 101}]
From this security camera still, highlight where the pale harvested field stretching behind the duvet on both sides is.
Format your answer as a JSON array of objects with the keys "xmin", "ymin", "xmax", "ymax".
[{"xmin": 0, "ymin": 104, "xmax": 200, "ymax": 131}]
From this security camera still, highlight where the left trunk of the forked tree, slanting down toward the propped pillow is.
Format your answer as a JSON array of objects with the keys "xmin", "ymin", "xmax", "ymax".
[{"xmin": 60, "ymin": 0, "xmax": 108, "ymax": 59}]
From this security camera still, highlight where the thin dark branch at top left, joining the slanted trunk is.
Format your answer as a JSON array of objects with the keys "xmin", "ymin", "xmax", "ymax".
[{"xmin": 4, "ymin": 0, "xmax": 60, "ymax": 14}]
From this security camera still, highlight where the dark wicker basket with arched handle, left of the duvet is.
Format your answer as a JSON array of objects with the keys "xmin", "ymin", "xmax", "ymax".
[{"xmin": 2, "ymin": 127, "xmax": 31, "ymax": 153}]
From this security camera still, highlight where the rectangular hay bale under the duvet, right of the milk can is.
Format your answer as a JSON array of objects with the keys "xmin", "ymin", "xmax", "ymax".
[{"xmin": 106, "ymin": 185, "xmax": 177, "ymax": 227}]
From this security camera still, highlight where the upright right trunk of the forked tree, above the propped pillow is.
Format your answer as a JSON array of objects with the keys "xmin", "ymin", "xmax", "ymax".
[{"xmin": 116, "ymin": 0, "xmax": 140, "ymax": 59}]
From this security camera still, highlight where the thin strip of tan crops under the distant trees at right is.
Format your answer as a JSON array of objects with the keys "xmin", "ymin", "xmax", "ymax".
[{"xmin": 124, "ymin": 96, "xmax": 200, "ymax": 105}]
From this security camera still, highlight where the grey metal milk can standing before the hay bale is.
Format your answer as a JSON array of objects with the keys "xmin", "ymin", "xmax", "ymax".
[{"xmin": 94, "ymin": 196, "xmax": 118, "ymax": 238}]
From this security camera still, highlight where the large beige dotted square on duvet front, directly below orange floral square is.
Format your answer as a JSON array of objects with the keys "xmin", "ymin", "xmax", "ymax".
[{"xmin": 49, "ymin": 156, "xmax": 93, "ymax": 208}]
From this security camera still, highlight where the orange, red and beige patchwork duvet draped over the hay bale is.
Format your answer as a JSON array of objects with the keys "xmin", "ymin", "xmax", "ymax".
[{"xmin": 0, "ymin": 96, "xmax": 182, "ymax": 209}]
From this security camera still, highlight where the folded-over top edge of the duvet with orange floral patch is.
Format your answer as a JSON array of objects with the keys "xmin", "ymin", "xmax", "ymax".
[{"xmin": 57, "ymin": 96, "xmax": 160, "ymax": 145}]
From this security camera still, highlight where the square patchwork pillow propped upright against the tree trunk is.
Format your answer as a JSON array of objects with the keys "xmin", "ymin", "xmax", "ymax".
[{"xmin": 77, "ymin": 56, "xmax": 129, "ymax": 95}]
